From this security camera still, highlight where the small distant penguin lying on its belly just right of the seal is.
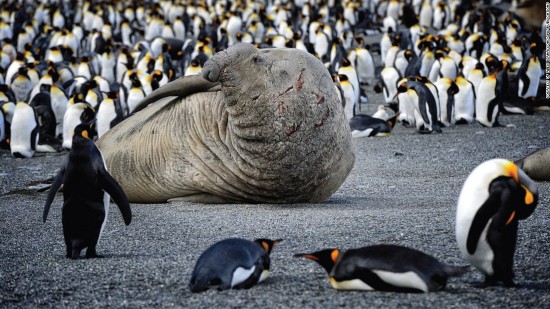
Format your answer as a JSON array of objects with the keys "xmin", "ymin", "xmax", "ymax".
[{"xmin": 349, "ymin": 114, "xmax": 399, "ymax": 137}]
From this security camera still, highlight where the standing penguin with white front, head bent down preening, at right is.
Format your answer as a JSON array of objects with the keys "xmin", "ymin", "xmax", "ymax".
[{"xmin": 456, "ymin": 159, "xmax": 538, "ymax": 286}]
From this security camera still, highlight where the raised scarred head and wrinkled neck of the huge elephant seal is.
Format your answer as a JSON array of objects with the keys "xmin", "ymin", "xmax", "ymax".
[{"xmin": 202, "ymin": 44, "xmax": 353, "ymax": 201}]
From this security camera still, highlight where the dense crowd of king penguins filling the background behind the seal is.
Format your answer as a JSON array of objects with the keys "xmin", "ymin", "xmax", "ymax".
[{"xmin": 0, "ymin": 0, "xmax": 545, "ymax": 157}]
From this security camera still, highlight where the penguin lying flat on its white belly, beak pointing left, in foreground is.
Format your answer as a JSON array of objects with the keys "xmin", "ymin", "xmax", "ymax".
[{"xmin": 294, "ymin": 245, "xmax": 468, "ymax": 293}]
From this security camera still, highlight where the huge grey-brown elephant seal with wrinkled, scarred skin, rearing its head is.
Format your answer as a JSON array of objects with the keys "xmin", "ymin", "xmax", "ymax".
[{"xmin": 97, "ymin": 43, "xmax": 355, "ymax": 203}]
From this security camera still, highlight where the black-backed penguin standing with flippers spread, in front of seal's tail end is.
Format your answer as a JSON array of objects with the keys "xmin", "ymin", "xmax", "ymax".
[{"xmin": 42, "ymin": 121, "xmax": 132, "ymax": 259}]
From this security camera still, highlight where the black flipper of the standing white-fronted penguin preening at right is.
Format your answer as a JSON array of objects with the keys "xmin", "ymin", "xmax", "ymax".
[{"xmin": 466, "ymin": 178, "xmax": 506, "ymax": 254}]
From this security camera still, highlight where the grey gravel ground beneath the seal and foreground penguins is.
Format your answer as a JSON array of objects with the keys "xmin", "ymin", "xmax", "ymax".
[{"xmin": 0, "ymin": 100, "xmax": 550, "ymax": 308}]
